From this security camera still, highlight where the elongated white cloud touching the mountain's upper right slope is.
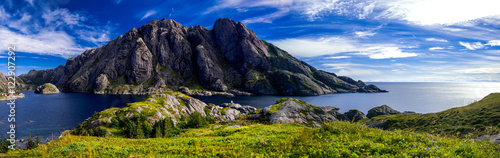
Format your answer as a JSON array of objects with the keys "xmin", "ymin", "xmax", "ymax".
[{"xmin": 270, "ymin": 37, "xmax": 359, "ymax": 57}]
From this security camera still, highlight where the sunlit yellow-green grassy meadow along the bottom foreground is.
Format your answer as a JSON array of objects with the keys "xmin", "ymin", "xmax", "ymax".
[{"xmin": 4, "ymin": 122, "xmax": 500, "ymax": 157}]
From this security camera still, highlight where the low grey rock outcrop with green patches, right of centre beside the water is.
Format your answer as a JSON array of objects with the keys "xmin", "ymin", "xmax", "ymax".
[{"xmin": 262, "ymin": 98, "xmax": 348, "ymax": 127}]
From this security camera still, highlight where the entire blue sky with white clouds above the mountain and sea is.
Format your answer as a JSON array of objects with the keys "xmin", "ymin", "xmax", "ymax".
[{"xmin": 0, "ymin": 0, "xmax": 500, "ymax": 82}]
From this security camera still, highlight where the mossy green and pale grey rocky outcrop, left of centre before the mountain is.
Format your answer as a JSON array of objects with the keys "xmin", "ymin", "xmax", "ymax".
[{"xmin": 79, "ymin": 91, "xmax": 220, "ymax": 129}]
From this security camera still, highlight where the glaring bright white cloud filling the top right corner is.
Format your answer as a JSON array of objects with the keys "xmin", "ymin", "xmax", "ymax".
[{"xmin": 381, "ymin": 0, "xmax": 500, "ymax": 25}]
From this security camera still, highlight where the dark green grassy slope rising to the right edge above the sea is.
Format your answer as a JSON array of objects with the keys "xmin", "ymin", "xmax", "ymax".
[{"xmin": 362, "ymin": 93, "xmax": 500, "ymax": 138}]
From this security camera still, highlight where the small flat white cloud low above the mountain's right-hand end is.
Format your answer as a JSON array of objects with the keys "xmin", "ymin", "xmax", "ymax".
[{"xmin": 358, "ymin": 46, "xmax": 418, "ymax": 59}]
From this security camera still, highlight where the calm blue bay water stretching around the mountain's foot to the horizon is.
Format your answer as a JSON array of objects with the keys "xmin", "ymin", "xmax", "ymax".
[{"xmin": 0, "ymin": 82, "xmax": 500, "ymax": 143}]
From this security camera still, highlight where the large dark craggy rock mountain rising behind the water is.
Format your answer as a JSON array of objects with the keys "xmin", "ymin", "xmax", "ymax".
[{"xmin": 20, "ymin": 18, "xmax": 384, "ymax": 95}]
